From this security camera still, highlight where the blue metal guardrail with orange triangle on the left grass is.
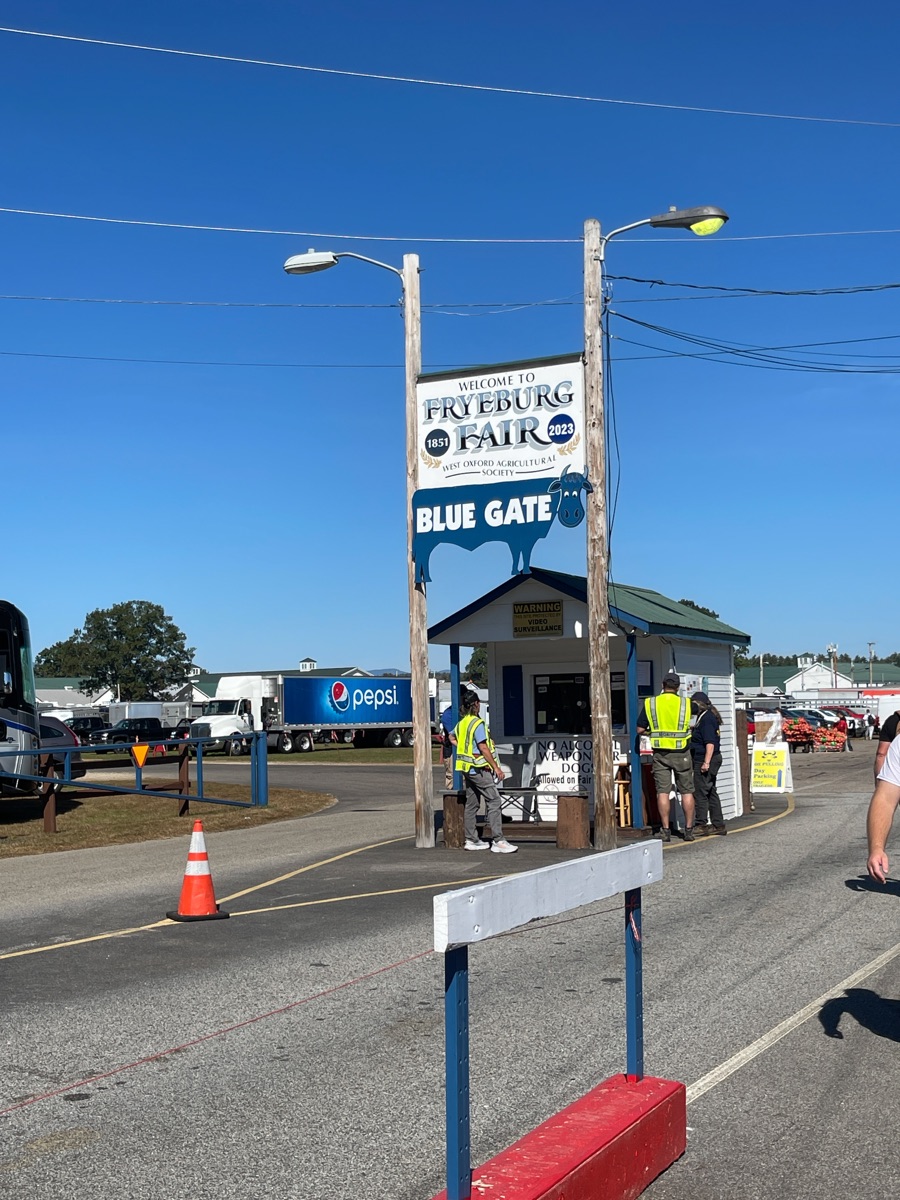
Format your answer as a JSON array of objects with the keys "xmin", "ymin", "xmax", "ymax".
[{"xmin": 0, "ymin": 730, "xmax": 269, "ymax": 833}]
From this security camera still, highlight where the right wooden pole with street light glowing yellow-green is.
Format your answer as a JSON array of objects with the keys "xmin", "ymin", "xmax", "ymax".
[{"xmin": 584, "ymin": 205, "xmax": 728, "ymax": 850}]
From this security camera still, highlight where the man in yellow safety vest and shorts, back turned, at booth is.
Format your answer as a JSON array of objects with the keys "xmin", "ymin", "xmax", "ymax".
[{"xmin": 637, "ymin": 671, "xmax": 694, "ymax": 841}]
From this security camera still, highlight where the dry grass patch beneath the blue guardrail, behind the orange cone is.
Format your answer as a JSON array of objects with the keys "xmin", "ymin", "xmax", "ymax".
[{"xmin": 0, "ymin": 778, "xmax": 332, "ymax": 858}]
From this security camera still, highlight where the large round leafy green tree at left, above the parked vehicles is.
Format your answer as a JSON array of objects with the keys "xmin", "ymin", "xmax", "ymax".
[{"xmin": 35, "ymin": 600, "xmax": 194, "ymax": 700}]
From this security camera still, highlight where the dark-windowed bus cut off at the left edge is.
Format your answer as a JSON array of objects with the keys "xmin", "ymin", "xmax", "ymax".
[{"xmin": 0, "ymin": 600, "xmax": 41, "ymax": 796}]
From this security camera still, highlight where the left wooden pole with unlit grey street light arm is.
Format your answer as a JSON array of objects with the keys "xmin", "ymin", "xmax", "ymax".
[{"xmin": 284, "ymin": 243, "xmax": 434, "ymax": 846}]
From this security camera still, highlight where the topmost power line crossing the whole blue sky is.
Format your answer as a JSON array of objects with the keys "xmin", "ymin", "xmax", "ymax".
[{"xmin": 0, "ymin": 25, "xmax": 900, "ymax": 130}]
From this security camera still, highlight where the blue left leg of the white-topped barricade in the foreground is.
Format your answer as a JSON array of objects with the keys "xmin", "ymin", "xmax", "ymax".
[{"xmin": 444, "ymin": 946, "xmax": 472, "ymax": 1200}]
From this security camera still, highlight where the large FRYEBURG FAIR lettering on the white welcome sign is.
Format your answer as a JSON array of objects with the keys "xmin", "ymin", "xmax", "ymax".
[{"xmin": 422, "ymin": 371, "xmax": 572, "ymax": 454}]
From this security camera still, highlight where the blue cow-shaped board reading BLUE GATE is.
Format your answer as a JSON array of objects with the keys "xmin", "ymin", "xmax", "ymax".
[{"xmin": 413, "ymin": 467, "xmax": 594, "ymax": 583}]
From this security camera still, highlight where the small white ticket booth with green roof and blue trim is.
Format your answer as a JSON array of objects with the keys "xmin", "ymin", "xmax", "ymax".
[{"xmin": 428, "ymin": 566, "xmax": 750, "ymax": 827}]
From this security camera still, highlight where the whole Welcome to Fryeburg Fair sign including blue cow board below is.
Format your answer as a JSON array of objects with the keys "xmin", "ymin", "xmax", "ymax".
[{"xmin": 413, "ymin": 354, "xmax": 593, "ymax": 582}]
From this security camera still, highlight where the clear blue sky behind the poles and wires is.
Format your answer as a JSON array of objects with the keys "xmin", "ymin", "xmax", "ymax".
[{"xmin": 0, "ymin": 0, "xmax": 900, "ymax": 671}]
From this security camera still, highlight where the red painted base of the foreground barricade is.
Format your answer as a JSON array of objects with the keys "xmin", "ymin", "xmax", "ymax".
[{"xmin": 434, "ymin": 1075, "xmax": 688, "ymax": 1200}]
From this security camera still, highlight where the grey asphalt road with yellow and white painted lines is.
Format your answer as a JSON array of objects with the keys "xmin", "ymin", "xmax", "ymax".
[{"xmin": 0, "ymin": 742, "xmax": 900, "ymax": 1200}]
